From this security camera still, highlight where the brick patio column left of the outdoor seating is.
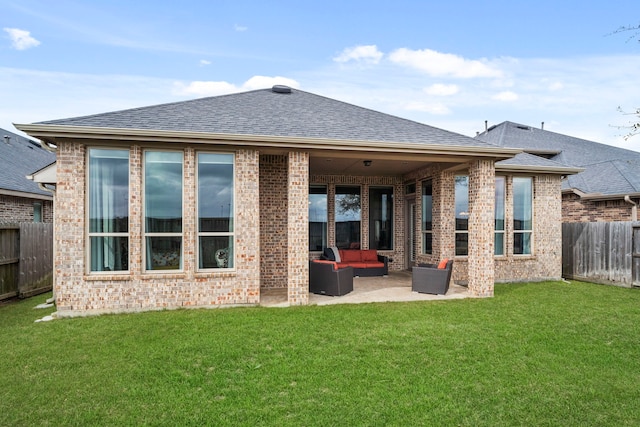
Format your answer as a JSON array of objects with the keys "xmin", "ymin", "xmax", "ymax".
[{"xmin": 287, "ymin": 151, "xmax": 309, "ymax": 305}]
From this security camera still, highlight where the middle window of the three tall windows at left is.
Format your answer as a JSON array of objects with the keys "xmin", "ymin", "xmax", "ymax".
[{"xmin": 144, "ymin": 151, "xmax": 183, "ymax": 270}]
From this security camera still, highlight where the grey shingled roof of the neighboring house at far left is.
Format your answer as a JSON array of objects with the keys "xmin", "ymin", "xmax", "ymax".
[{"xmin": 0, "ymin": 129, "xmax": 56, "ymax": 199}]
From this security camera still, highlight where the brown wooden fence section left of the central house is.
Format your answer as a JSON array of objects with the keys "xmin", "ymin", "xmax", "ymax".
[{"xmin": 0, "ymin": 223, "xmax": 53, "ymax": 300}]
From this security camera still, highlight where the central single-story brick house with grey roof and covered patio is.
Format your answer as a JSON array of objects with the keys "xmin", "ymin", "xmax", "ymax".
[{"xmin": 17, "ymin": 86, "xmax": 578, "ymax": 316}]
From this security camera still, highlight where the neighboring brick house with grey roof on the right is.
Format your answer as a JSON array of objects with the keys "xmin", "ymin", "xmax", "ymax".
[{"xmin": 476, "ymin": 122, "xmax": 640, "ymax": 222}]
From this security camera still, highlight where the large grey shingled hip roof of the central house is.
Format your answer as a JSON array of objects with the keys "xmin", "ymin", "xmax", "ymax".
[{"xmin": 38, "ymin": 86, "xmax": 491, "ymax": 147}]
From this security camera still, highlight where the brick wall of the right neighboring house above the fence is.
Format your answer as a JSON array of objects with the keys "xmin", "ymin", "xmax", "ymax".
[{"xmin": 562, "ymin": 193, "xmax": 640, "ymax": 222}]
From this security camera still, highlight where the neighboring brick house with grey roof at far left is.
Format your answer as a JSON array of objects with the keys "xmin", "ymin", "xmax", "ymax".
[{"xmin": 0, "ymin": 129, "xmax": 55, "ymax": 223}]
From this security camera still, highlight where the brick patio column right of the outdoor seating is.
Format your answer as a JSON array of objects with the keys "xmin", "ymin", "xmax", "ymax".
[{"xmin": 468, "ymin": 160, "xmax": 495, "ymax": 297}]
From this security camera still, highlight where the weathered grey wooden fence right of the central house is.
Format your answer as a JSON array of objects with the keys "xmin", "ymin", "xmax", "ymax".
[{"xmin": 562, "ymin": 222, "xmax": 640, "ymax": 287}]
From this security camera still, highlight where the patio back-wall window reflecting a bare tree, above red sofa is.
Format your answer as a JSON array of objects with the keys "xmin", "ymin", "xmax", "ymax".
[{"xmin": 335, "ymin": 186, "xmax": 361, "ymax": 249}]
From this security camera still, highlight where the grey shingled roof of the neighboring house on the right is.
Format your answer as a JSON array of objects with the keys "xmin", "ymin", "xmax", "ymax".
[{"xmin": 476, "ymin": 122, "xmax": 640, "ymax": 198}]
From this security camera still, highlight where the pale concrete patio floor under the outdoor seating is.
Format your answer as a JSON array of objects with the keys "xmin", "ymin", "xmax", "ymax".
[{"xmin": 260, "ymin": 270, "xmax": 474, "ymax": 307}]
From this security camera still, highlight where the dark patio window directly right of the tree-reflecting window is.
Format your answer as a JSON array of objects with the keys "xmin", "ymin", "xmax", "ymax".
[{"xmin": 369, "ymin": 187, "xmax": 393, "ymax": 249}]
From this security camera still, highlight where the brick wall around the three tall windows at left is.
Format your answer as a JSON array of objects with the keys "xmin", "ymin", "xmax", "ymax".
[{"xmin": 54, "ymin": 142, "xmax": 260, "ymax": 316}]
